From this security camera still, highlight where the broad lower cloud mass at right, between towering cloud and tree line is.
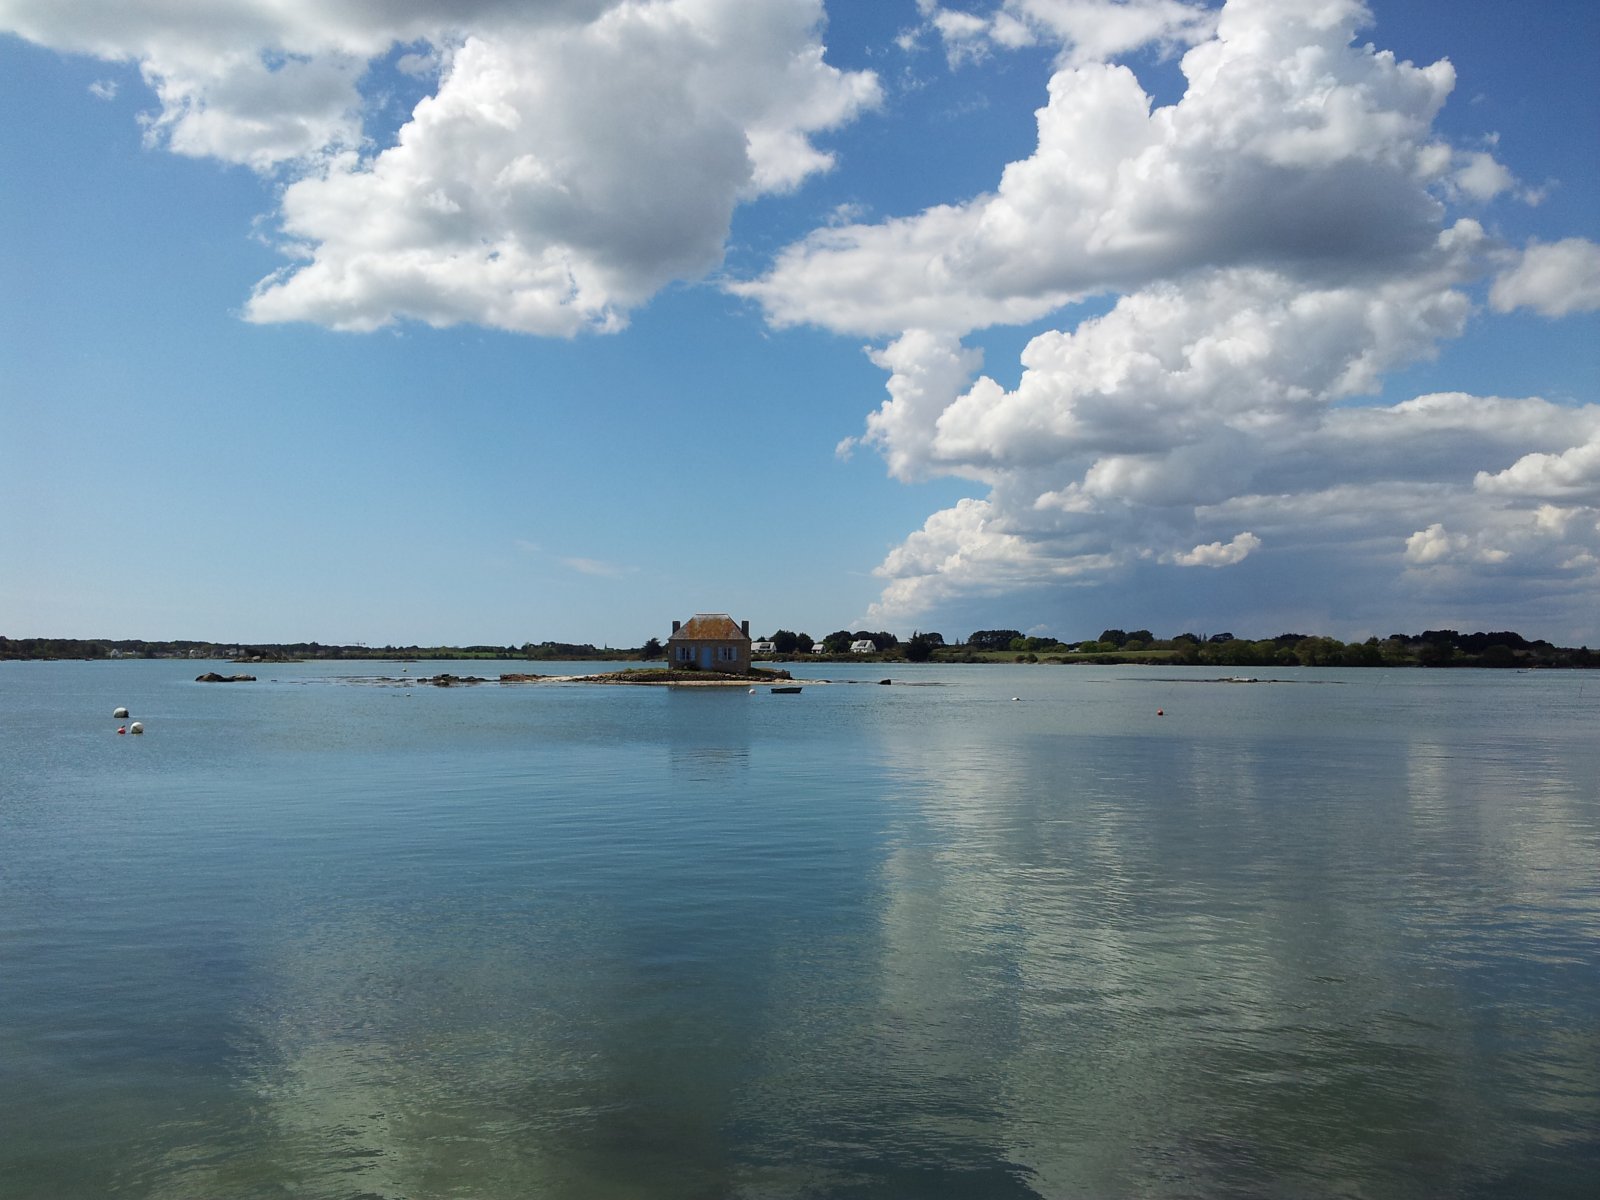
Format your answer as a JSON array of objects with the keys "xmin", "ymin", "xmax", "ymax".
[{"xmin": 862, "ymin": 259, "xmax": 1600, "ymax": 629}]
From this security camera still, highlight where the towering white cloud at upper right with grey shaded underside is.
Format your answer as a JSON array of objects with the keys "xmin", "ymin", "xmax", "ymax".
[{"xmin": 738, "ymin": 0, "xmax": 1482, "ymax": 334}]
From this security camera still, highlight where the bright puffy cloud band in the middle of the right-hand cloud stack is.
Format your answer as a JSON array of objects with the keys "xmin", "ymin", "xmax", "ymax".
[{"xmin": 867, "ymin": 240, "xmax": 1482, "ymax": 499}]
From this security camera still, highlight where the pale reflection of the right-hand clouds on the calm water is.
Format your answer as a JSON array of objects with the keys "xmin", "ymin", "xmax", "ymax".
[{"xmin": 882, "ymin": 672, "xmax": 1600, "ymax": 1195}]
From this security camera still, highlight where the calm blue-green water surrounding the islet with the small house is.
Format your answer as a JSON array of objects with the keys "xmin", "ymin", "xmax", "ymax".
[{"xmin": 0, "ymin": 662, "xmax": 1600, "ymax": 1200}]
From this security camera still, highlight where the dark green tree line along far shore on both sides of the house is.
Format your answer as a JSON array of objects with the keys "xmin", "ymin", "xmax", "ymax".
[{"xmin": 0, "ymin": 629, "xmax": 1600, "ymax": 669}]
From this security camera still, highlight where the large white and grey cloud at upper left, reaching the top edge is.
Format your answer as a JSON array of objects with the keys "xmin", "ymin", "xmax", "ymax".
[{"xmin": 0, "ymin": 0, "xmax": 878, "ymax": 334}]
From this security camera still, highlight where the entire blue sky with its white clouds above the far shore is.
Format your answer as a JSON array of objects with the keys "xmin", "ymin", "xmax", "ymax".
[{"xmin": 0, "ymin": 0, "xmax": 1600, "ymax": 645}]
